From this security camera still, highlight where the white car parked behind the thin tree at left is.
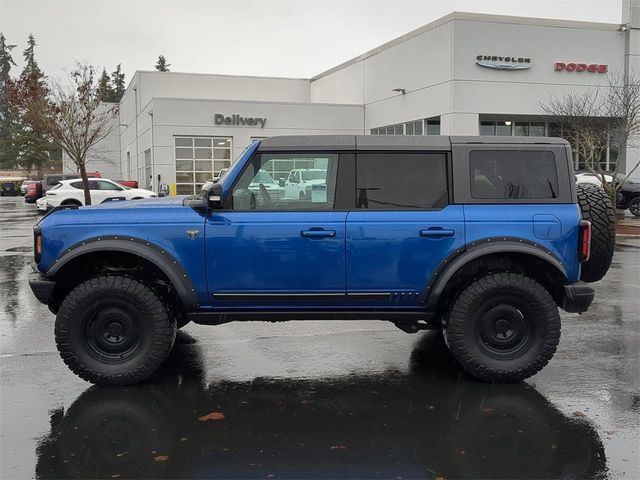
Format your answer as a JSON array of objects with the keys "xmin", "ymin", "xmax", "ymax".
[{"xmin": 36, "ymin": 178, "xmax": 157, "ymax": 211}]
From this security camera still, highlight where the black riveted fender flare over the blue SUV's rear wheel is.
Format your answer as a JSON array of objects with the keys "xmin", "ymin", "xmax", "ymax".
[{"xmin": 424, "ymin": 237, "xmax": 577, "ymax": 313}]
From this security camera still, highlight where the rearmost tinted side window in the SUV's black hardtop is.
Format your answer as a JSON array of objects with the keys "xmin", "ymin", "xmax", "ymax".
[{"xmin": 469, "ymin": 150, "xmax": 558, "ymax": 199}]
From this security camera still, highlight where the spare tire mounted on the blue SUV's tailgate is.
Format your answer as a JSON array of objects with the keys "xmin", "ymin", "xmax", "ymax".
[{"xmin": 577, "ymin": 185, "xmax": 616, "ymax": 282}]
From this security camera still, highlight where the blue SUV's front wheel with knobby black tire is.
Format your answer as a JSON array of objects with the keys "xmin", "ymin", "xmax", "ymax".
[{"xmin": 55, "ymin": 276, "xmax": 176, "ymax": 385}]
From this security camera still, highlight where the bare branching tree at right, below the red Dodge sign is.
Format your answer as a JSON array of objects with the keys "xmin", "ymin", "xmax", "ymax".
[{"xmin": 540, "ymin": 67, "xmax": 640, "ymax": 204}]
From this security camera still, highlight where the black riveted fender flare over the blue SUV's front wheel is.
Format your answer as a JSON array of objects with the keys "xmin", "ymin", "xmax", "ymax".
[{"xmin": 45, "ymin": 236, "xmax": 199, "ymax": 312}]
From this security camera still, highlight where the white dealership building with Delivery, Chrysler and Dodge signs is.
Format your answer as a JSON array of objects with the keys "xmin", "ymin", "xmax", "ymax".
[{"xmin": 80, "ymin": 0, "xmax": 640, "ymax": 194}]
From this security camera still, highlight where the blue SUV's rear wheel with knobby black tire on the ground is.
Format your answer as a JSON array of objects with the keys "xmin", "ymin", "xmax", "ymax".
[{"xmin": 443, "ymin": 273, "xmax": 560, "ymax": 383}]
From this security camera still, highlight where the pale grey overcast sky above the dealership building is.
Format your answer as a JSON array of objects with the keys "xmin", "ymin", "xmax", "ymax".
[{"xmin": 0, "ymin": 0, "xmax": 622, "ymax": 83}]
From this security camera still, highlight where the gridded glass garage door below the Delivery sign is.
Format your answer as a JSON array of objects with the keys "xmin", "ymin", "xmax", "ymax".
[{"xmin": 174, "ymin": 137, "xmax": 232, "ymax": 195}]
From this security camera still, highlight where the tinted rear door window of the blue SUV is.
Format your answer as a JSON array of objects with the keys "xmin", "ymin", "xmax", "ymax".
[{"xmin": 356, "ymin": 153, "xmax": 447, "ymax": 210}]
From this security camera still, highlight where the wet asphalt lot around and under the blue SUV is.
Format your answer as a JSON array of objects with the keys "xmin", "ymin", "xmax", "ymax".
[{"xmin": 0, "ymin": 197, "xmax": 640, "ymax": 479}]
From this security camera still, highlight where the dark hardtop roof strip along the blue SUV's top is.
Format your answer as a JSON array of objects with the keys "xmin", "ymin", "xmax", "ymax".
[{"xmin": 258, "ymin": 135, "xmax": 569, "ymax": 151}]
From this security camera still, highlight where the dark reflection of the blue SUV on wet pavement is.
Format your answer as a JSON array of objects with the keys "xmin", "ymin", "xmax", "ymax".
[{"xmin": 36, "ymin": 334, "xmax": 606, "ymax": 478}]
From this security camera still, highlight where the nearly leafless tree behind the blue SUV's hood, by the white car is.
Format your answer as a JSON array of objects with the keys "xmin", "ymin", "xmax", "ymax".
[{"xmin": 22, "ymin": 63, "xmax": 119, "ymax": 205}]
